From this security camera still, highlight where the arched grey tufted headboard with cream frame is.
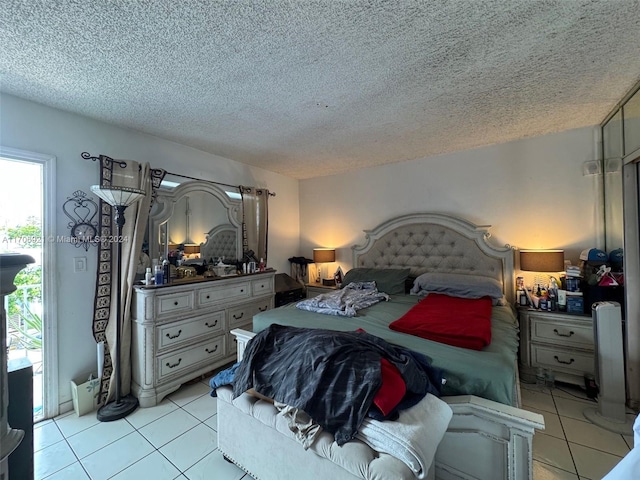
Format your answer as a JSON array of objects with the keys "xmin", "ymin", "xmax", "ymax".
[{"xmin": 351, "ymin": 213, "xmax": 515, "ymax": 303}]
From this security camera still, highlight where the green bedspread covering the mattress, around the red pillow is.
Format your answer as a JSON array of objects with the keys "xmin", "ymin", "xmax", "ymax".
[{"xmin": 253, "ymin": 295, "xmax": 518, "ymax": 405}]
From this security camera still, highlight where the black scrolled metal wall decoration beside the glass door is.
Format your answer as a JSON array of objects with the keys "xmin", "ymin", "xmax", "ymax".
[{"xmin": 62, "ymin": 190, "xmax": 99, "ymax": 251}]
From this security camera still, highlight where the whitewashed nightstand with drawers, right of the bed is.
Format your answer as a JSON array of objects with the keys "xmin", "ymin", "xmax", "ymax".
[{"xmin": 518, "ymin": 307, "xmax": 595, "ymax": 386}]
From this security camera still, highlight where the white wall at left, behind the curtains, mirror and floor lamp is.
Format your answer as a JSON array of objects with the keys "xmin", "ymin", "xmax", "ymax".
[{"xmin": 0, "ymin": 94, "xmax": 299, "ymax": 404}]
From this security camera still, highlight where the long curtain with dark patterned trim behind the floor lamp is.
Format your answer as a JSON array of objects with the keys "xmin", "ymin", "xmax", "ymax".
[{"xmin": 93, "ymin": 155, "xmax": 165, "ymax": 404}]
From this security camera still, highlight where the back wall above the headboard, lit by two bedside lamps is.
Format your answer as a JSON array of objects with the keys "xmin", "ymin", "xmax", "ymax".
[{"xmin": 300, "ymin": 128, "xmax": 602, "ymax": 280}]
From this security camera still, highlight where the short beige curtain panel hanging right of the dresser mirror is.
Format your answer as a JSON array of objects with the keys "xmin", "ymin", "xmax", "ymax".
[{"xmin": 238, "ymin": 185, "xmax": 270, "ymax": 263}]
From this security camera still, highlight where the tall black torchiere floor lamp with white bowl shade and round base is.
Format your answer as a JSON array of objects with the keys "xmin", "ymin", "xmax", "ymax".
[{"xmin": 91, "ymin": 185, "xmax": 146, "ymax": 422}]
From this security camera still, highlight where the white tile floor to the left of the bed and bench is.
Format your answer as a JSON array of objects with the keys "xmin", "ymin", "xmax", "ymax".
[{"xmin": 34, "ymin": 379, "xmax": 251, "ymax": 480}]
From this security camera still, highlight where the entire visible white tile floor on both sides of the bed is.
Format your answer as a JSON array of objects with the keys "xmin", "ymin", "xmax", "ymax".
[{"xmin": 34, "ymin": 380, "xmax": 633, "ymax": 480}]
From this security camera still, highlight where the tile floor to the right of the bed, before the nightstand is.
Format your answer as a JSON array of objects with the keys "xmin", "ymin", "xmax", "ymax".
[{"xmin": 521, "ymin": 384, "xmax": 635, "ymax": 480}]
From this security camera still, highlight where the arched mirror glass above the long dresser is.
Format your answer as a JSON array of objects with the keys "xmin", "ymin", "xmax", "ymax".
[{"xmin": 149, "ymin": 174, "xmax": 243, "ymax": 263}]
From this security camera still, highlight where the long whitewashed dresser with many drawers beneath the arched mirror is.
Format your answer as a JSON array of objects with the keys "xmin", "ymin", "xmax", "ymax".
[{"xmin": 131, "ymin": 270, "xmax": 275, "ymax": 407}]
